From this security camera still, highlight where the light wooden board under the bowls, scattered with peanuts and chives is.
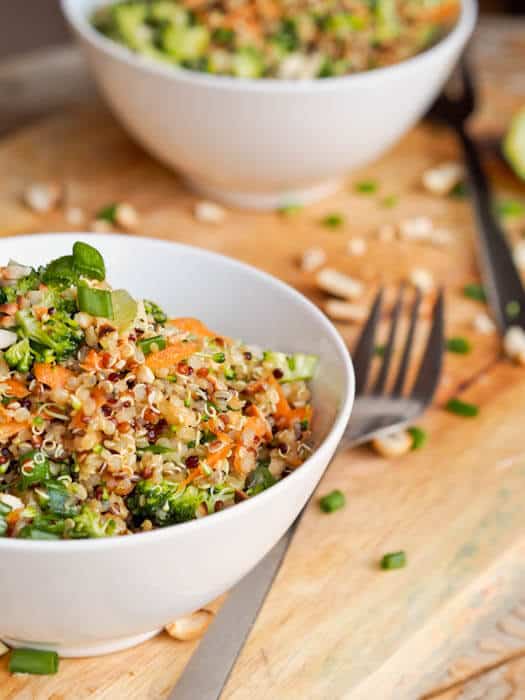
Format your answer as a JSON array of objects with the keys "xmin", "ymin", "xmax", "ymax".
[{"xmin": 0, "ymin": 20, "xmax": 525, "ymax": 700}]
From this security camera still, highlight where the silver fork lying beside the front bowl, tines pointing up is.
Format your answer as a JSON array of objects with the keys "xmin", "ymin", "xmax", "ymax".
[{"xmin": 168, "ymin": 288, "xmax": 444, "ymax": 700}]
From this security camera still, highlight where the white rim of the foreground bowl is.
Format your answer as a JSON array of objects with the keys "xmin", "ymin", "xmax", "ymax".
[{"xmin": 0, "ymin": 231, "xmax": 355, "ymax": 554}]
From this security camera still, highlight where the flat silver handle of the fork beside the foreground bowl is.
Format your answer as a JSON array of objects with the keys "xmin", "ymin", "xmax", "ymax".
[{"xmin": 168, "ymin": 516, "xmax": 300, "ymax": 700}]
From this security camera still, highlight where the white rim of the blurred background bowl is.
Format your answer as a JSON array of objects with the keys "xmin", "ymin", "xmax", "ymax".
[{"xmin": 60, "ymin": 0, "xmax": 478, "ymax": 94}]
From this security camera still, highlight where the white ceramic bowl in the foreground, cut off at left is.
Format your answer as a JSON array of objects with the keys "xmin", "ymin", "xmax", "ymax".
[{"xmin": 0, "ymin": 234, "xmax": 354, "ymax": 656}]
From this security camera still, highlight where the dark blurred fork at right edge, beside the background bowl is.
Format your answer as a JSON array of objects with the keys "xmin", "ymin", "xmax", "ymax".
[{"xmin": 428, "ymin": 56, "xmax": 525, "ymax": 332}]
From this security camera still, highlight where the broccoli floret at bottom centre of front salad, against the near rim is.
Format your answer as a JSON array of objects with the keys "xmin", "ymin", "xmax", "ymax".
[{"xmin": 127, "ymin": 481, "xmax": 209, "ymax": 527}]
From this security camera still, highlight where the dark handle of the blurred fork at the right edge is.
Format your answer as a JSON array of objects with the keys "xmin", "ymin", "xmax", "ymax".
[{"xmin": 457, "ymin": 125, "xmax": 525, "ymax": 331}]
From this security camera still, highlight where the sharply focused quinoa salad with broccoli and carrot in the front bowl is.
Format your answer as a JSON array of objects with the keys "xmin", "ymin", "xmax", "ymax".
[{"xmin": 0, "ymin": 242, "xmax": 317, "ymax": 540}]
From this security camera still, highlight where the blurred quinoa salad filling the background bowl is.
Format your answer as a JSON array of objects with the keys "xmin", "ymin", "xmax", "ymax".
[{"xmin": 92, "ymin": 0, "xmax": 460, "ymax": 79}]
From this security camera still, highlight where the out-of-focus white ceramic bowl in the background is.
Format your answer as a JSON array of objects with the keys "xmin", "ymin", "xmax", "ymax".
[{"xmin": 62, "ymin": 0, "xmax": 477, "ymax": 209}]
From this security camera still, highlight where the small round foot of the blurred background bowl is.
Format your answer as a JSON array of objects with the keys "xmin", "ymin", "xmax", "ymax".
[{"xmin": 185, "ymin": 177, "xmax": 343, "ymax": 211}]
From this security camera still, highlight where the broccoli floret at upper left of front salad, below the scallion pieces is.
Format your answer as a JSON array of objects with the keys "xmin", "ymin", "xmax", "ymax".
[{"xmin": 15, "ymin": 309, "xmax": 84, "ymax": 362}]
